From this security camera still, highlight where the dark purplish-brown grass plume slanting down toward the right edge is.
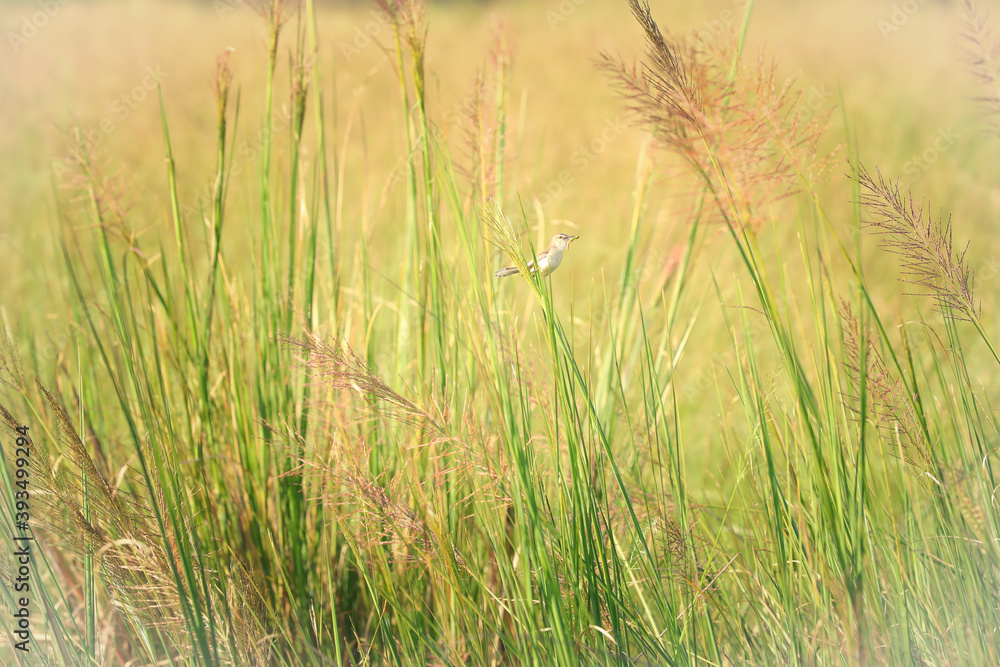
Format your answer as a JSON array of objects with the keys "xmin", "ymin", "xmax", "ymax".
[{"xmin": 851, "ymin": 163, "xmax": 980, "ymax": 321}]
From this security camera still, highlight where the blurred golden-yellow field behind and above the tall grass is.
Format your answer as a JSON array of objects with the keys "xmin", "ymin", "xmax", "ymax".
[{"xmin": 0, "ymin": 0, "xmax": 1000, "ymax": 321}]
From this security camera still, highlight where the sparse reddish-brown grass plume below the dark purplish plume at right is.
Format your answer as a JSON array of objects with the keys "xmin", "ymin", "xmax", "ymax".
[{"xmin": 840, "ymin": 300, "xmax": 931, "ymax": 470}]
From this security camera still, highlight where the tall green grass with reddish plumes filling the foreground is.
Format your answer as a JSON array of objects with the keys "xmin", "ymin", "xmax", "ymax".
[{"xmin": 0, "ymin": 0, "xmax": 1000, "ymax": 665}]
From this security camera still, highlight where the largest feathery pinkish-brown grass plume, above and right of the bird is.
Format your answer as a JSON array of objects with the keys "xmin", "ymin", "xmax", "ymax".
[{"xmin": 599, "ymin": 0, "xmax": 836, "ymax": 231}]
